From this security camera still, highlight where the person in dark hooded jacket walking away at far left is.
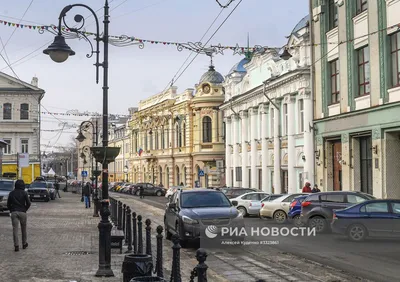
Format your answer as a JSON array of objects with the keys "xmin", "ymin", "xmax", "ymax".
[{"xmin": 7, "ymin": 180, "xmax": 31, "ymax": 252}]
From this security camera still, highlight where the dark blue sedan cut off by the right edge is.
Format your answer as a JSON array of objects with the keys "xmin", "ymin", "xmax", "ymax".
[{"xmin": 331, "ymin": 199, "xmax": 400, "ymax": 241}]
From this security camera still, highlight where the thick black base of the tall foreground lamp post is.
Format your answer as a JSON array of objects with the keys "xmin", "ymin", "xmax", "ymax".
[{"xmin": 95, "ymin": 201, "xmax": 114, "ymax": 277}]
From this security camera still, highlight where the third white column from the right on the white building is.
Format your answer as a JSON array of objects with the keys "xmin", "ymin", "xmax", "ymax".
[{"xmin": 274, "ymin": 102, "xmax": 282, "ymax": 194}]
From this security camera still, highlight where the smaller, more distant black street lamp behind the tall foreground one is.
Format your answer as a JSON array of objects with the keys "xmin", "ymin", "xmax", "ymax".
[{"xmin": 75, "ymin": 119, "xmax": 101, "ymax": 217}]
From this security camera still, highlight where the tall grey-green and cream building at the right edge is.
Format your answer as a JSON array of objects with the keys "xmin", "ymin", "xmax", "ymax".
[{"xmin": 311, "ymin": 0, "xmax": 400, "ymax": 198}]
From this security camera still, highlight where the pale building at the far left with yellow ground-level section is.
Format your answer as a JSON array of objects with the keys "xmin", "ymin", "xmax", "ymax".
[{"xmin": 0, "ymin": 72, "xmax": 45, "ymax": 183}]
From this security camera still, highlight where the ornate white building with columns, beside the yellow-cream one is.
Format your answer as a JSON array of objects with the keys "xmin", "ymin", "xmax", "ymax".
[{"xmin": 221, "ymin": 16, "xmax": 314, "ymax": 193}]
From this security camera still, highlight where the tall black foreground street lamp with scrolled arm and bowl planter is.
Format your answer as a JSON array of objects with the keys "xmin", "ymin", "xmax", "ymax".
[{"xmin": 43, "ymin": 0, "xmax": 120, "ymax": 277}]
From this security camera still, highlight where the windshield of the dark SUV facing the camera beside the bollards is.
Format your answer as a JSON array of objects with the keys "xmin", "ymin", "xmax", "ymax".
[{"xmin": 181, "ymin": 192, "xmax": 231, "ymax": 208}]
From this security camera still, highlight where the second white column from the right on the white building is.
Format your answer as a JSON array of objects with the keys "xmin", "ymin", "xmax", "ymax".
[{"xmin": 286, "ymin": 96, "xmax": 297, "ymax": 193}]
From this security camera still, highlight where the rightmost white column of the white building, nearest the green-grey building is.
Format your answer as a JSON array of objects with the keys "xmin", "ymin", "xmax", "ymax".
[{"xmin": 303, "ymin": 94, "xmax": 315, "ymax": 184}]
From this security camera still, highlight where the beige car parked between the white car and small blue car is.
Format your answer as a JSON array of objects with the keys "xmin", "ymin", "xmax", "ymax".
[{"xmin": 260, "ymin": 193, "xmax": 305, "ymax": 224}]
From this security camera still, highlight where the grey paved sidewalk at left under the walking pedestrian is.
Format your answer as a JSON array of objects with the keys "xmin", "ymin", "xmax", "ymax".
[{"xmin": 0, "ymin": 192, "xmax": 124, "ymax": 282}]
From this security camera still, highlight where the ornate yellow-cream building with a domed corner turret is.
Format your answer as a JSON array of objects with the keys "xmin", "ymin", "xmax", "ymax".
[{"xmin": 129, "ymin": 66, "xmax": 224, "ymax": 187}]
